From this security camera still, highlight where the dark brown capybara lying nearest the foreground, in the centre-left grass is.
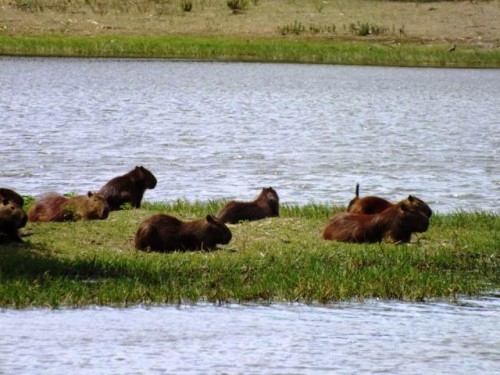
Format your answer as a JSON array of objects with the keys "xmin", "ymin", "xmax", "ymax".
[{"xmin": 134, "ymin": 214, "xmax": 232, "ymax": 252}]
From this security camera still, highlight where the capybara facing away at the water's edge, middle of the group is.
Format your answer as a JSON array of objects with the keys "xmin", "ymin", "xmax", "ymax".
[{"xmin": 217, "ymin": 187, "xmax": 280, "ymax": 224}]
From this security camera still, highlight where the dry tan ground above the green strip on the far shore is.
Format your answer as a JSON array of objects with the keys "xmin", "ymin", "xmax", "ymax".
[{"xmin": 0, "ymin": 0, "xmax": 500, "ymax": 48}]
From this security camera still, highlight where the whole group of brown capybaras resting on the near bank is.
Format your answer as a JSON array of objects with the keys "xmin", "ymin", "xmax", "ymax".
[{"xmin": 0, "ymin": 166, "xmax": 432, "ymax": 252}]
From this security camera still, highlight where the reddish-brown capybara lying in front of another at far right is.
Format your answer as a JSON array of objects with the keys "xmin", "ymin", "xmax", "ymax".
[{"xmin": 323, "ymin": 203, "xmax": 429, "ymax": 243}]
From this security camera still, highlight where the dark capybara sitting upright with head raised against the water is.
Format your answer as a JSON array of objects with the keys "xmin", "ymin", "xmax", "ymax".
[{"xmin": 99, "ymin": 166, "xmax": 156, "ymax": 211}]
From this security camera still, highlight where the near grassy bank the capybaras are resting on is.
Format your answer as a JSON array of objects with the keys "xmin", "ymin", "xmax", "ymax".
[{"xmin": 0, "ymin": 201, "xmax": 500, "ymax": 308}]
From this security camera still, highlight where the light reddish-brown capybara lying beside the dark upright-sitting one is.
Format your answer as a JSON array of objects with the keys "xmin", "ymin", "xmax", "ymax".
[{"xmin": 28, "ymin": 191, "xmax": 110, "ymax": 222}]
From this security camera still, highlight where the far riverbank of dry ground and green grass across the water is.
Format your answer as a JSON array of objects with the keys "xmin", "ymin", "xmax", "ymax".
[{"xmin": 0, "ymin": 0, "xmax": 500, "ymax": 67}]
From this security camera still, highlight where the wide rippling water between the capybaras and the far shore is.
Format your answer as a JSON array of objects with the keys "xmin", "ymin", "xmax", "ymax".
[{"xmin": 0, "ymin": 57, "xmax": 500, "ymax": 212}]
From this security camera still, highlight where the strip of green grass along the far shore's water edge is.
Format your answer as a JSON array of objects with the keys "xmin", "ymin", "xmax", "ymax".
[{"xmin": 0, "ymin": 35, "xmax": 500, "ymax": 67}]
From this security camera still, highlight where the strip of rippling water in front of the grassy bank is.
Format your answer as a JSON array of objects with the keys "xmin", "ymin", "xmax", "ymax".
[{"xmin": 0, "ymin": 297, "xmax": 500, "ymax": 374}]
